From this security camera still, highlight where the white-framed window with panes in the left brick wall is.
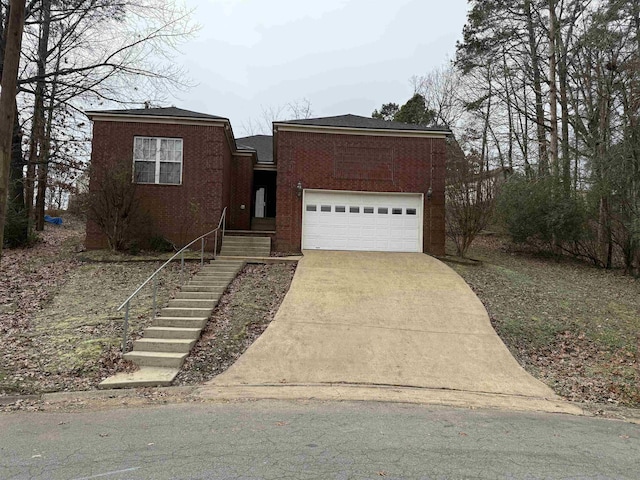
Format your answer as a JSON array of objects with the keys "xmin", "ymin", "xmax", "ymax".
[{"xmin": 133, "ymin": 137, "xmax": 182, "ymax": 185}]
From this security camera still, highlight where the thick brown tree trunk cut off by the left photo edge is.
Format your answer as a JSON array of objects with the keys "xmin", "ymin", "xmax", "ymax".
[{"xmin": 0, "ymin": 0, "xmax": 25, "ymax": 260}]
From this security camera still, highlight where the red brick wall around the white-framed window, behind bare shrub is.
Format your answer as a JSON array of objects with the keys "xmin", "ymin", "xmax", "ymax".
[{"xmin": 86, "ymin": 121, "xmax": 231, "ymax": 249}]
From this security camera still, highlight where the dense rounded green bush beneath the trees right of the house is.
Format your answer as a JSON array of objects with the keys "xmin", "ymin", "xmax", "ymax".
[{"xmin": 497, "ymin": 175, "xmax": 587, "ymax": 248}]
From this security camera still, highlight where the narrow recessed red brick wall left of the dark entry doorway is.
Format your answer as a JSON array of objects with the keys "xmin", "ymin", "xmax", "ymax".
[{"xmin": 227, "ymin": 156, "xmax": 254, "ymax": 230}]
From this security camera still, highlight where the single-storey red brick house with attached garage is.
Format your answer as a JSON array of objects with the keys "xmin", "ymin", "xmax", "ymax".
[{"xmin": 86, "ymin": 107, "xmax": 450, "ymax": 255}]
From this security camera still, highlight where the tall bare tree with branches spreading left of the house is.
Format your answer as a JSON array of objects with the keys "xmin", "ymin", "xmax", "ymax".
[{"xmin": 8, "ymin": 0, "xmax": 197, "ymax": 236}]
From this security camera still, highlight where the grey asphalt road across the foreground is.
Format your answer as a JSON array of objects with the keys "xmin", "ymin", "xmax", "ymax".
[{"xmin": 0, "ymin": 401, "xmax": 640, "ymax": 480}]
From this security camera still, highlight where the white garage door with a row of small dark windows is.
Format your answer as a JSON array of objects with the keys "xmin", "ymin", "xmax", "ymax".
[{"xmin": 302, "ymin": 190, "xmax": 422, "ymax": 252}]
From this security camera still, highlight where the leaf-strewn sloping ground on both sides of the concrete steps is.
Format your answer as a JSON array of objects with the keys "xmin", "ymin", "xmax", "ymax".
[{"xmin": 0, "ymin": 218, "xmax": 295, "ymax": 408}]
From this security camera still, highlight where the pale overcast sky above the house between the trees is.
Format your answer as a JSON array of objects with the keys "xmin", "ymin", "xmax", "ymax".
[{"xmin": 176, "ymin": 0, "xmax": 467, "ymax": 136}]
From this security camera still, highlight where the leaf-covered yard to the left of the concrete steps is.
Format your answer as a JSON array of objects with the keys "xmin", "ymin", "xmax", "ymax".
[{"xmin": 0, "ymin": 217, "xmax": 197, "ymax": 395}]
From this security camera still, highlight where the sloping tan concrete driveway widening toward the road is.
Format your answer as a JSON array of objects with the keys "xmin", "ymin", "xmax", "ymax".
[{"xmin": 201, "ymin": 251, "xmax": 578, "ymax": 413}]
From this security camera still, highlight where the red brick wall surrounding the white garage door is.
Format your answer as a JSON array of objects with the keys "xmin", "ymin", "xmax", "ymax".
[{"xmin": 274, "ymin": 127, "xmax": 446, "ymax": 255}]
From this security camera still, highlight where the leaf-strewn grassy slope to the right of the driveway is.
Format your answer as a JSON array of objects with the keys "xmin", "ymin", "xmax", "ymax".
[{"xmin": 450, "ymin": 237, "xmax": 640, "ymax": 411}]
